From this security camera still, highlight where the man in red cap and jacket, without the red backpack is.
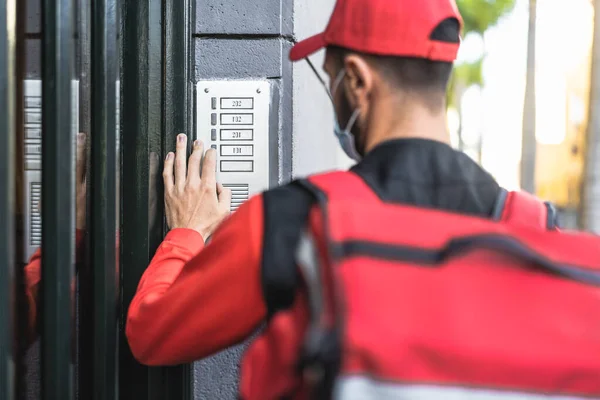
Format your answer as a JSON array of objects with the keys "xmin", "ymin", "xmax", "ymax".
[{"xmin": 127, "ymin": 0, "xmax": 492, "ymax": 365}]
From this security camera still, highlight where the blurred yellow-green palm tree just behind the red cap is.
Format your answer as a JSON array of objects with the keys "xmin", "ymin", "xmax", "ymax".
[{"xmin": 447, "ymin": 0, "xmax": 515, "ymax": 149}]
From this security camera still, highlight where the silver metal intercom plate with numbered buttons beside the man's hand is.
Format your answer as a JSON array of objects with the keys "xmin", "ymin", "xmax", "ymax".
[{"xmin": 196, "ymin": 81, "xmax": 271, "ymax": 211}]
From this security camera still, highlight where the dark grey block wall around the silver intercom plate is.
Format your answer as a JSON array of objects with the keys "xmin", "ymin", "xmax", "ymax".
[{"xmin": 193, "ymin": 0, "xmax": 293, "ymax": 400}]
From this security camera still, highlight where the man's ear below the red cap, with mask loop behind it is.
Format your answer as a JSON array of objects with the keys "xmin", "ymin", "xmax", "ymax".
[{"xmin": 344, "ymin": 54, "xmax": 374, "ymax": 108}]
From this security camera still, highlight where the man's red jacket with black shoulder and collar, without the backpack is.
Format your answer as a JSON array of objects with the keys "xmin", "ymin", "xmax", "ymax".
[{"xmin": 126, "ymin": 139, "xmax": 506, "ymax": 365}]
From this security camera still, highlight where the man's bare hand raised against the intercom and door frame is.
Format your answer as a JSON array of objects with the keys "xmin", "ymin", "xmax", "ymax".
[{"xmin": 163, "ymin": 134, "xmax": 231, "ymax": 241}]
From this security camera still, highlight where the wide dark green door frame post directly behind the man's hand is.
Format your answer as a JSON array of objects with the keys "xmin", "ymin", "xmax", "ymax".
[{"xmin": 119, "ymin": 0, "xmax": 193, "ymax": 400}]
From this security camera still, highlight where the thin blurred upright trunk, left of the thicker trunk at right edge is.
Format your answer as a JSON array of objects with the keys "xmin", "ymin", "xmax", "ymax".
[{"xmin": 521, "ymin": 0, "xmax": 537, "ymax": 194}]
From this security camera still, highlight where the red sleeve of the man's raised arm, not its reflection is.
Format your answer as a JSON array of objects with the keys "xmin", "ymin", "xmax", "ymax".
[{"xmin": 126, "ymin": 196, "xmax": 266, "ymax": 365}]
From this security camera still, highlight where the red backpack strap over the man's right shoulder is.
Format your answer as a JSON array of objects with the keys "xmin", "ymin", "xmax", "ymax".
[{"xmin": 492, "ymin": 189, "xmax": 558, "ymax": 230}]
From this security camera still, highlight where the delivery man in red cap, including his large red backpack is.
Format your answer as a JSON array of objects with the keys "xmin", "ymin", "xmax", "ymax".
[{"xmin": 126, "ymin": 0, "xmax": 600, "ymax": 400}]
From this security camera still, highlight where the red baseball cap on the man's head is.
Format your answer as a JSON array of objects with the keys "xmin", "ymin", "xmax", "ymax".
[{"xmin": 290, "ymin": 0, "xmax": 462, "ymax": 62}]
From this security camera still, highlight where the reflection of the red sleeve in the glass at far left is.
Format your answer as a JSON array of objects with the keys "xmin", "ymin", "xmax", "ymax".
[{"xmin": 24, "ymin": 230, "xmax": 84, "ymax": 342}]
